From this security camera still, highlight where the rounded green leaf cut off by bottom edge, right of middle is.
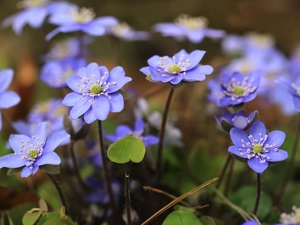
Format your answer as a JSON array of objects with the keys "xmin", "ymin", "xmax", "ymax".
[{"xmin": 162, "ymin": 209, "xmax": 202, "ymax": 225}]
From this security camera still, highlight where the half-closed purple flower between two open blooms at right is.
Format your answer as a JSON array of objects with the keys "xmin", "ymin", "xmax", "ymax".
[{"xmin": 215, "ymin": 110, "xmax": 258, "ymax": 132}]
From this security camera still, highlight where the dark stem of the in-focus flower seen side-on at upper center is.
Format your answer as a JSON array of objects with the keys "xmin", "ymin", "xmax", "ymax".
[{"xmin": 156, "ymin": 86, "xmax": 174, "ymax": 183}]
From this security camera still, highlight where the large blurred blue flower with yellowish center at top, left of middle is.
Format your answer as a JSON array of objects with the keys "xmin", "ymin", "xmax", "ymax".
[{"xmin": 46, "ymin": 8, "xmax": 118, "ymax": 40}]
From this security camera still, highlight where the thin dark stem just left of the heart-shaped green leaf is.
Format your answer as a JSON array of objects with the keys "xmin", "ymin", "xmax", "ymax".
[{"xmin": 98, "ymin": 120, "xmax": 119, "ymax": 225}]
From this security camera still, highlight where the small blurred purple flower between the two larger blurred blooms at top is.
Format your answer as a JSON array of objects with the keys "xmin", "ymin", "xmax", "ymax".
[{"xmin": 108, "ymin": 23, "xmax": 150, "ymax": 41}]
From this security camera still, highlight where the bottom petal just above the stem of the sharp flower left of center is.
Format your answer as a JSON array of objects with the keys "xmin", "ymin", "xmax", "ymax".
[{"xmin": 92, "ymin": 95, "xmax": 110, "ymax": 120}]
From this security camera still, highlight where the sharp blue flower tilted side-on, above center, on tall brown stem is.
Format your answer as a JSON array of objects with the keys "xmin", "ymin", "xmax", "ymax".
[{"xmin": 140, "ymin": 50, "xmax": 213, "ymax": 85}]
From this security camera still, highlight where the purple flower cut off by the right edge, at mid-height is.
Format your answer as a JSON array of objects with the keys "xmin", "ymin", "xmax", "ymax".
[{"xmin": 276, "ymin": 76, "xmax": 300, "ymax": 112}]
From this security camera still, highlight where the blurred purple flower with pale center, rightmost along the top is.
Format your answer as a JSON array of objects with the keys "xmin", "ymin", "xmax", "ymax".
[{"xmin": 154, "ymin": 14, "xmax": 225, "ymax": 44}]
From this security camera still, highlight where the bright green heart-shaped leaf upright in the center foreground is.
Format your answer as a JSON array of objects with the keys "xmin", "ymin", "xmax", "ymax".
[{"xmin": 107, "ymin": 134, "xmax": 146, "ymax": 164}]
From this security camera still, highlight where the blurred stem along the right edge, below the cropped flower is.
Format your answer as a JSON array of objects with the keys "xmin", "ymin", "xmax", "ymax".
[{"xmin": 277, "ymin": 113, "xmax": 300, "ymax": 199}]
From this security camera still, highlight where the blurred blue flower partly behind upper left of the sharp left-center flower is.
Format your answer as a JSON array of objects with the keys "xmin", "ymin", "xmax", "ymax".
[{"xmin": 40, "ymin": 57, "xmax": 86, "ymax": 88}]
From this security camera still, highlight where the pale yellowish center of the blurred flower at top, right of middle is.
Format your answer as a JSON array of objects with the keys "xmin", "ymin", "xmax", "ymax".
[{"xmin": 175, "ymin": 14, "xmax": 208, "ymax": 30}]
